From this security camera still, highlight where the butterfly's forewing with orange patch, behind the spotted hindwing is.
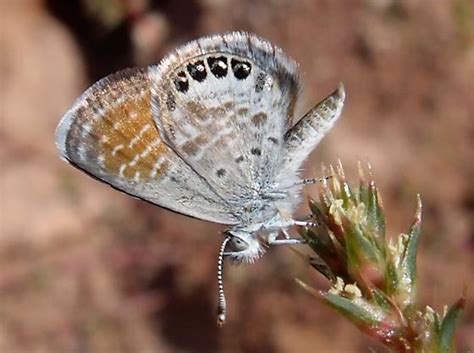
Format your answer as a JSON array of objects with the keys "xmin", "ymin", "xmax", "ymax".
[{"xmin": 56, "ymin": 69, "xmax": 238, "ymax": 224}]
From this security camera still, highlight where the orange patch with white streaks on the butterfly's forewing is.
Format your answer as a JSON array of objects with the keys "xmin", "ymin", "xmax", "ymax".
[{"xmin": 93, "ymin": 93, "xmax": 170, "ymax": 181}]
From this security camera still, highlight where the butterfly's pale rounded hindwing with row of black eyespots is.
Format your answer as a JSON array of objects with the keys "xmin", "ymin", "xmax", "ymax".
[{"xmin": 149, "ymin": 33, "xmax": 299, "ymax": 203}]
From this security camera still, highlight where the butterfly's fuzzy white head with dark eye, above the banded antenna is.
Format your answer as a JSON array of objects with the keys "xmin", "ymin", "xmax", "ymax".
[{"xmin": 224, "ymin": 230, "xmax": 265, "ymax": 263}]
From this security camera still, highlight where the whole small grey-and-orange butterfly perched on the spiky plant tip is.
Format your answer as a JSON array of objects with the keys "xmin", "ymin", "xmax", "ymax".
[{"xmin": 56, "ymin": 32, "xmax": 345, "ymax": 324}]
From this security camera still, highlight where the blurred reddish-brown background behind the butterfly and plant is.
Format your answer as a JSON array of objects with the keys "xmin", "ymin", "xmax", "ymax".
[{"xmin": 0, "ymin": 0, "xmax": 474, "ymax": 353}]
